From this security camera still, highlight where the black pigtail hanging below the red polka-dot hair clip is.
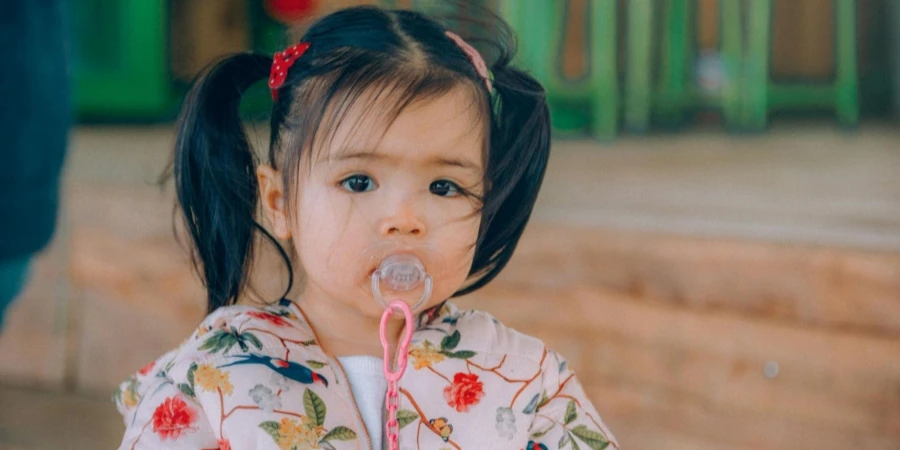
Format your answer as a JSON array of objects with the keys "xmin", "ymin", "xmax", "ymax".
[{"xmin": 173, "ymin": 53, "xmax": 290, "ymax": 312}]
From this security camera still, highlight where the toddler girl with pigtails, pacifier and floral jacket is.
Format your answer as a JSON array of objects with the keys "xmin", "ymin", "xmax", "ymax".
[{"xmin": 116, "ymin": 7, "xmax": 617, "ymax": 450}]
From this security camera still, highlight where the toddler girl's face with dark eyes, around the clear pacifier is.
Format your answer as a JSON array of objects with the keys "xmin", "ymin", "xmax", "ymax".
[{"xmin": 270, "ymin": 89, "xmax": 484, "ymax": 317}]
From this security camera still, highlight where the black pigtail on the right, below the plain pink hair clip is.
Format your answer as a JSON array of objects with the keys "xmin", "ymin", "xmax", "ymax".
[{"xmin": 456, "ymin": 63, "xmax": 550, "ymax": 295}]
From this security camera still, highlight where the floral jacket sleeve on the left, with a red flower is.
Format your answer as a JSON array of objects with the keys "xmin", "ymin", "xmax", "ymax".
[{"xmin": 115, "ymin": 376, "xmax": 219, "ymax": 450}]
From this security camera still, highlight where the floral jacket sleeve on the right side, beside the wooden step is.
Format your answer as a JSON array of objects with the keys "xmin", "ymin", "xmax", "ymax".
[{"xmin": 527, "ymin": 350, "xmax": 619, "ymax": 450}]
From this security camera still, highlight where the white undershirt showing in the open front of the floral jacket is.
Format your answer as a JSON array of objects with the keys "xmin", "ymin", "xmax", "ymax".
[{"xmin": 338, "ymin": 355, "xmax": 387, "ymax": 449}]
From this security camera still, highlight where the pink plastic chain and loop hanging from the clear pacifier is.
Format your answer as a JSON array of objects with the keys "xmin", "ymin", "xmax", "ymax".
[{"xmin": 379, "ymin": 300, "xmax": 413, "ymax": 450}]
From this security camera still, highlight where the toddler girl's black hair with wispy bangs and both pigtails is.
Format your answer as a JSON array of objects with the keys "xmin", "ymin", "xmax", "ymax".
[{"xmin": 173, "ymin": 6, "xmax": 550, "ymax": 312}]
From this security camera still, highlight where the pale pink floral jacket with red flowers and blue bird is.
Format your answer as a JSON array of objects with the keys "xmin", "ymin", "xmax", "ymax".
[{"xmin": 114, "ymin": 300, "xmax": 618, "ymax": 450}]
